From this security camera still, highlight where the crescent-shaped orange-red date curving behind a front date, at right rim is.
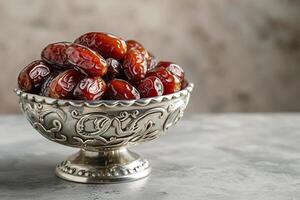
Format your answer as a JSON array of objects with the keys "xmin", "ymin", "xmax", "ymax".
[{"xmin": 147, "ymin": 67, "xmax": 181, "ymax": 95}]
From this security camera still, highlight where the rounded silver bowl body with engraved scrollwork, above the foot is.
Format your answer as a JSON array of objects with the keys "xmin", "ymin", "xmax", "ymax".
[{"xmin": 15, "ymin": 83, "xmax": 189, "ymax": 151}]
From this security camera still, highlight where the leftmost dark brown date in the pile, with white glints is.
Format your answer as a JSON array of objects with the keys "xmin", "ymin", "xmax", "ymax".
[{"xmin": 18, "ymin": 60, "xmax": 50, "ymax": 93}]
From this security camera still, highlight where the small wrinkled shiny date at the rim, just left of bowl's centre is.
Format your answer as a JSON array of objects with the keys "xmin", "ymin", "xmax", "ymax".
[{"xmin": 73, "ymin": 77, "xmax": 106, "ymax": 101}]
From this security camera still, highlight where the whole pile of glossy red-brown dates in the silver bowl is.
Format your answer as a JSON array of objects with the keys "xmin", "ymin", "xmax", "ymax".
[{"xmin": 18, "ymin": 32, "xmax": 187, "ymax": 100}]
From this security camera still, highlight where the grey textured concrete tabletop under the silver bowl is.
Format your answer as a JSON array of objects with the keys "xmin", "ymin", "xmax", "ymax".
[{"xmin": 0, "ymin": 114, "xmax": 300, "ymax": 200}]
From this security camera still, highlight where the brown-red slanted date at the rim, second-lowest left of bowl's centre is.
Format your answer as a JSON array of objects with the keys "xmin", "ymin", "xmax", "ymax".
[{"xmin": 49, "ymin": 69, "xmax": 82, "ymax": 99}]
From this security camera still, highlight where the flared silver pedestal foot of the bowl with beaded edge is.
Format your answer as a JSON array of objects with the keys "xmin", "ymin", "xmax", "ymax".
[{"xmin": 55, "ymin": 148, "xmax": 151, "ymax": 183}]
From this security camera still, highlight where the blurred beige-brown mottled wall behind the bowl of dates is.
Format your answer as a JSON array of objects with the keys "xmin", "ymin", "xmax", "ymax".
[{"xmin": 0, "ymin": 0, "xmax": 300, "ymax": 113}]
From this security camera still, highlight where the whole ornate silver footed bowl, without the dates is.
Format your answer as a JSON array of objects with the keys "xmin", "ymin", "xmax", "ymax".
[{"xmin": 15, "ymin": 84, "xmax": 193, "ymax": 183}]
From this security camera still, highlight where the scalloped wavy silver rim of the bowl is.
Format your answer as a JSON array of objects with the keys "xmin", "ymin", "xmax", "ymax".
[{"xmin": 14, "ymin": 83, "xmax": 194, "ymax": 107}]
